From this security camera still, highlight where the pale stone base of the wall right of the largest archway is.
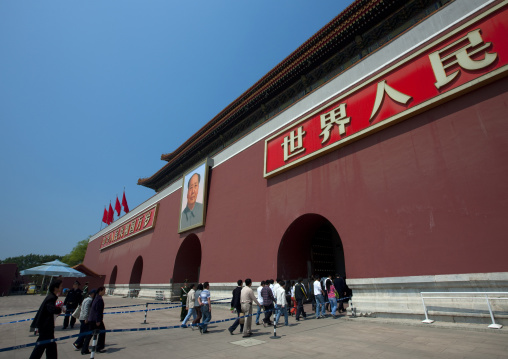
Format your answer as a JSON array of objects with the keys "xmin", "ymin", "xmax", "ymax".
[{"xmin": 347, "ymin": 272, "xmax": 508, "ymax": 325}]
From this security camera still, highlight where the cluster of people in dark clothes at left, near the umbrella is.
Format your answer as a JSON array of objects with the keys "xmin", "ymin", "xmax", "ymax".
[{"xmin": 30, "ymin": 279, "xmax": 106, "ymax": 359}]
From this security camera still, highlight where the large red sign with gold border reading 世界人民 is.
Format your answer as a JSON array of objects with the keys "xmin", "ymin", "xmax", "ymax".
[{"xmin": 264, "ymin": 1, "xmax": 508, "ymax": 178}]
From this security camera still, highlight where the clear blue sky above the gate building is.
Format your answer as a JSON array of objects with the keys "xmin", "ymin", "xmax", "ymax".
[{"xmin": 0, "ymin": 0, "xmax": 352, "ymax": 259}]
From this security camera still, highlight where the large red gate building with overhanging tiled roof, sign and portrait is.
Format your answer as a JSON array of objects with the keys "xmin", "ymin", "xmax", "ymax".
[{"xmin": 84, "ymin": 0, "xmax": 508, "ymax": 320}]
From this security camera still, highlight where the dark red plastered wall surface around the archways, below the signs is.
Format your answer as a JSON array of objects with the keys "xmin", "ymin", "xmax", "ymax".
[{"xmin": 84, "ymin": 79, "xmax": 508, "ymax": 284}]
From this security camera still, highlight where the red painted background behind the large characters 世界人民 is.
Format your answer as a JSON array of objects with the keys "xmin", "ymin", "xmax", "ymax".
[{"xmin": 265, "ymin": 7, "xmax": 508, "ymax": 176}]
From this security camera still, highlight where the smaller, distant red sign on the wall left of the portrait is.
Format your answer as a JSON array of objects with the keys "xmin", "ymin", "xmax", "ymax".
[{"xmin": 100, "ymin": 203, "xmax": 159, "ymax": 250}]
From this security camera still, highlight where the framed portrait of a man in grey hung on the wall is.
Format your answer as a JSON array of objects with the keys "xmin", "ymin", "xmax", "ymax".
[{"xmin": 178, "ymin": 161, "xmax": 208, "ymax": 233}]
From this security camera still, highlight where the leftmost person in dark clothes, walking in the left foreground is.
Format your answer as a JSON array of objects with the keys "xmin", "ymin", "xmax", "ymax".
[{"xmin": 30, "ymin": 279, "xmax": 63, "ymax": 359}]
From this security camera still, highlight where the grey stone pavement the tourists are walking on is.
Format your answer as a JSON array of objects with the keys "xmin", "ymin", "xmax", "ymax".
[{"xmin": 0, "ymin": 293, "xmax": 508, "ymax": 359}]
